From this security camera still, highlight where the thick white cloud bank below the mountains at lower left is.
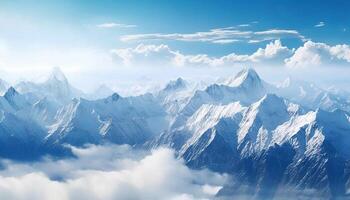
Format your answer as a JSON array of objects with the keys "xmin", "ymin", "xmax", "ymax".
[{"xmin": 0, "ymin": 145, "xmax": 228, "ymax": 200}]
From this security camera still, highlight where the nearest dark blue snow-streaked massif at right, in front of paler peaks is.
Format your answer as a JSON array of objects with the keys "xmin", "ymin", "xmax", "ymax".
[{"xmin": 153, "ymin": 86, "xmax": 350, "ymax": 198}]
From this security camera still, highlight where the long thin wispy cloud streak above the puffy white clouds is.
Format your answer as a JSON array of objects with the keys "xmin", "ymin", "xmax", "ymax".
[{"xmin": 120, "ymin": 27, "xmax": 305, "ymax": 44}]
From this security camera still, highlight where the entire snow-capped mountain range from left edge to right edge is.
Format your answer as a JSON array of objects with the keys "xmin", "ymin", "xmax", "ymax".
[{"xmin": 0, "ymin": 68, "xmax": 350, "ymax": 199}]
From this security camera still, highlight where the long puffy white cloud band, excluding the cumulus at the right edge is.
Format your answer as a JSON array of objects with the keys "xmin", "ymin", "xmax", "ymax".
[{"xmin": 112, "ymin": 40, "xmax": 293, "ymax": 66}]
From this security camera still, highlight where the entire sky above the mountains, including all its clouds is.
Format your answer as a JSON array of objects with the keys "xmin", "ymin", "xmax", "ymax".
[{"xmin": 0, "ymin": 0, "xmax": 350, "ymax": 92}]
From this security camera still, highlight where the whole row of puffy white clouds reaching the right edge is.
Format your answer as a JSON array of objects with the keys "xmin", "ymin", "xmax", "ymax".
[{"xmin": 111, "ymin": 40, "xmax": 350, "ymax": 68}]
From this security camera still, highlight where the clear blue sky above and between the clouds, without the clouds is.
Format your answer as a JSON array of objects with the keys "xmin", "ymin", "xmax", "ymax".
[{"xmin": 0, "ymin": 0, "xmax": 350, "ymax": 51}]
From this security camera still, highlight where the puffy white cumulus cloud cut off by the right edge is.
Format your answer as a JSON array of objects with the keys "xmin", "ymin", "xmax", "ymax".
[{"xmin": 285, "ymin": 41, "xmax": 350, "ymax": 67}]
